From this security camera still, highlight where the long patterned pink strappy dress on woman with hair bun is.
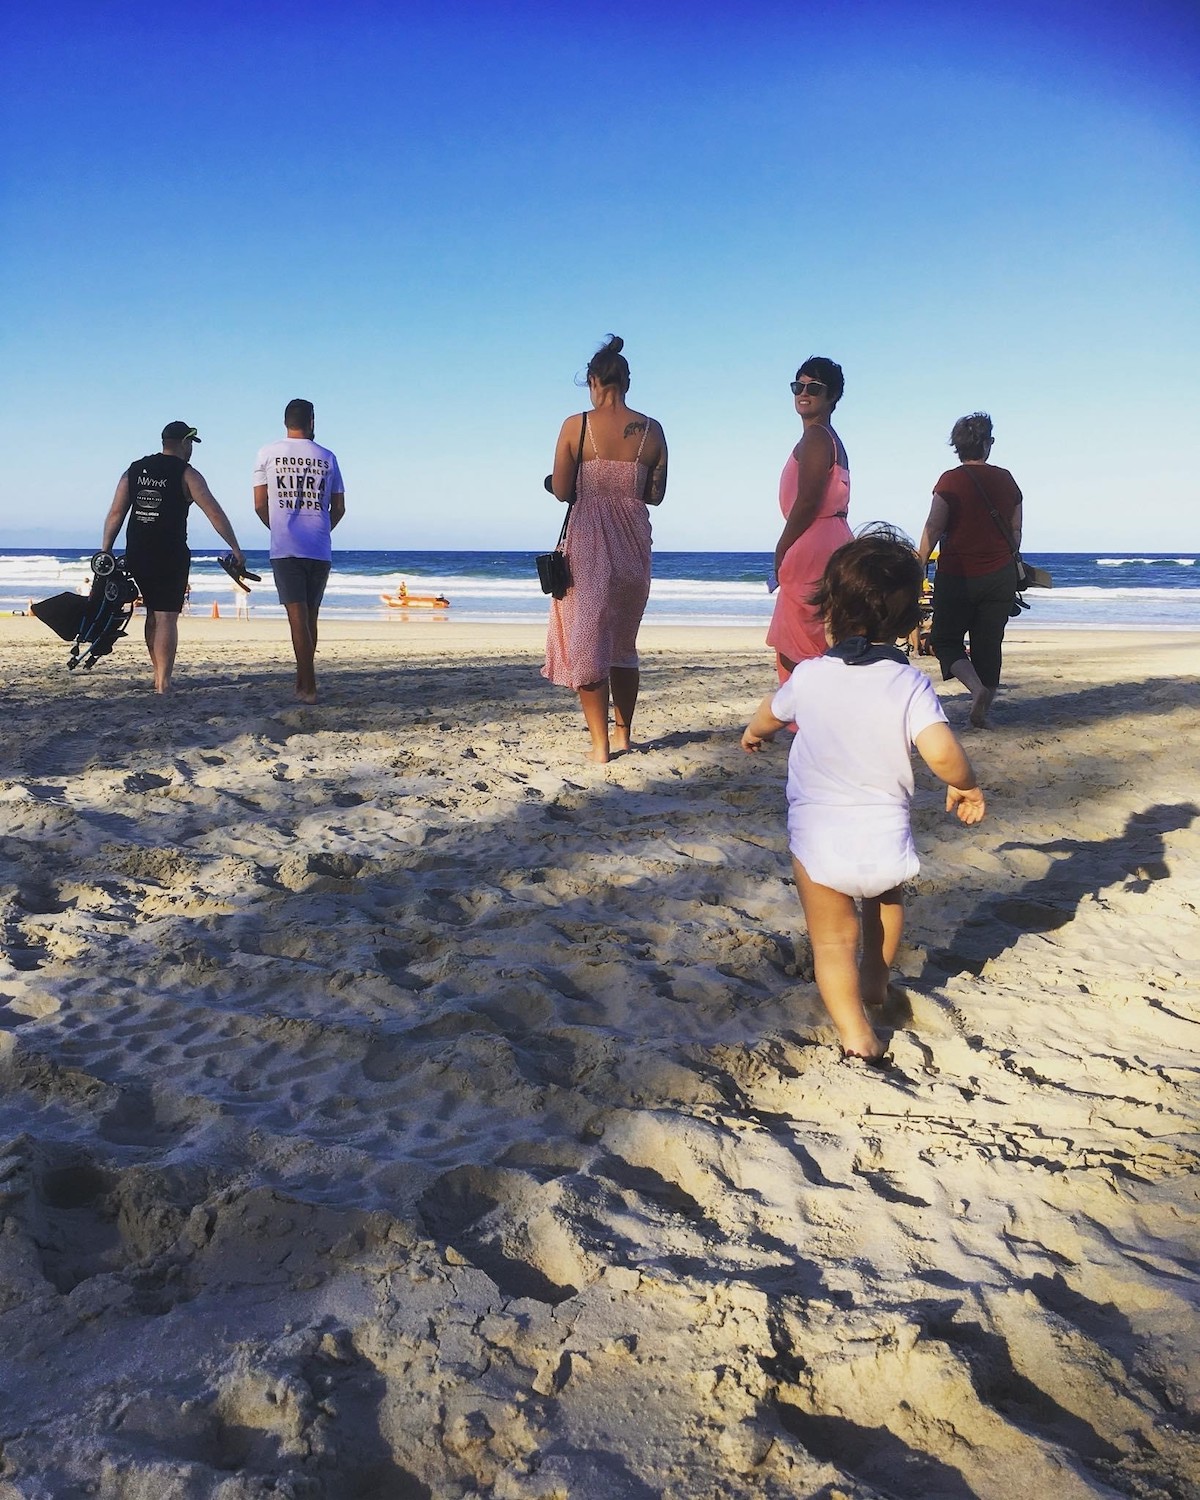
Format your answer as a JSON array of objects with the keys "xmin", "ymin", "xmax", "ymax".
[{"xmin": 542, "ymin": 420, "xmax": 651, "ymax": 689}]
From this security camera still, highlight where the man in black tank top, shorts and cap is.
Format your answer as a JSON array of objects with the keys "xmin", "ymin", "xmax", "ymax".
[{"xmin": 101, "ymin": 422, "xmax": 246, "ymax": 693}]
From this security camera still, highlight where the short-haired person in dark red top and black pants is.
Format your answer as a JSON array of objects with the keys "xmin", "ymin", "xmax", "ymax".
[{"xmin": 920, "ymin": 411, "xmax": 1022, "ymax": 729}]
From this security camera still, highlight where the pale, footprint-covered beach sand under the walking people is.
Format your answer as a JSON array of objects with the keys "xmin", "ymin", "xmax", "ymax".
[{"xmin": 0, "ymin": 620, "xmax": 1200, "ymax": 1500}]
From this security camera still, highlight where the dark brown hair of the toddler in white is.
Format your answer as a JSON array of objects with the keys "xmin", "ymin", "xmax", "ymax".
[{"xmin": 812, "ymin": 522, "xmax": 926, "ymax": 642}]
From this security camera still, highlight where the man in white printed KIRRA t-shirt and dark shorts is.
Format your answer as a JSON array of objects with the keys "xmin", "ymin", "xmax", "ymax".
[{"xmin": 254, "ymin": 399, "xmax": 347, "ymax": 704}]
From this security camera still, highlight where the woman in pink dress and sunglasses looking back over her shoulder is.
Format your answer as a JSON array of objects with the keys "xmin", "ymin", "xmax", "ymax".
[{"xmin": 767, "ymin": 356, "xmax": 854, "ymax": 683}]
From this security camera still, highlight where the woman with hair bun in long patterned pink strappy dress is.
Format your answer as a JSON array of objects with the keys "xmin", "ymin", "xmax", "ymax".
[{"xmin": 542, "ymin": 336, "xmax": 666, "ymax": 765}]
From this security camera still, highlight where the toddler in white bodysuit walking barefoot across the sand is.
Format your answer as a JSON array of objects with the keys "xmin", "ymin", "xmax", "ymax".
[{"xmin": 741, "ymin": 528, "xmax": 984, "ymax": 1067}]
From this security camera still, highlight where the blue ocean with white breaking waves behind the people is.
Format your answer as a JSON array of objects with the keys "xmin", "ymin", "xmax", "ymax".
[{"xmin": 0, "ymin": 548, "xmax": 1200, "ymax": 630}]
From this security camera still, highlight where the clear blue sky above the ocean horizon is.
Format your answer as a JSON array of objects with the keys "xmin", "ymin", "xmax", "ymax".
[{"xmin": 0, "ymin": 0, "xmax": 1200, "ymax": 552}]
